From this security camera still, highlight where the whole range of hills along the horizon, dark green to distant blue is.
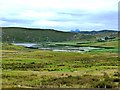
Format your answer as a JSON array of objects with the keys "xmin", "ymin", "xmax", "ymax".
[{"xmin": 2, "ymin": 27, "xmax": 118, "ymax": 43}]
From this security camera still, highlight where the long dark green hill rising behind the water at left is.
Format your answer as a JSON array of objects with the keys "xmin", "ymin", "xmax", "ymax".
[{"xmin": 2, "ymin": 27, "xmax": 75, "ymax": 43}]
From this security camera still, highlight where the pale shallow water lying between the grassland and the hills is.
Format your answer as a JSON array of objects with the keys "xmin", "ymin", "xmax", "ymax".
[{"xmin": 12, "ymin": 43, "xmax": 100, "ymax": 52}]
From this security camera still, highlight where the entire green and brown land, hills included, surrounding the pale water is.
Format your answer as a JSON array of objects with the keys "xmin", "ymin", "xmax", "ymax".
[{"xmin": 1, "ymin": 27, "xmax": 120, "ymax": 89}]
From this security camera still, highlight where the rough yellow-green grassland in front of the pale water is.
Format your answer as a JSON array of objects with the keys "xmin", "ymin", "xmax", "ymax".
[{"xmin": 2, "ymin": 42, "xmax": 120, "ymax": 88}]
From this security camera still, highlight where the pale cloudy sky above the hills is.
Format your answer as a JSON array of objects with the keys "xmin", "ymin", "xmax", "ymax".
[{"xmin": 0, "ymin": 0, "xmax": 119, "ymax": 31}]
